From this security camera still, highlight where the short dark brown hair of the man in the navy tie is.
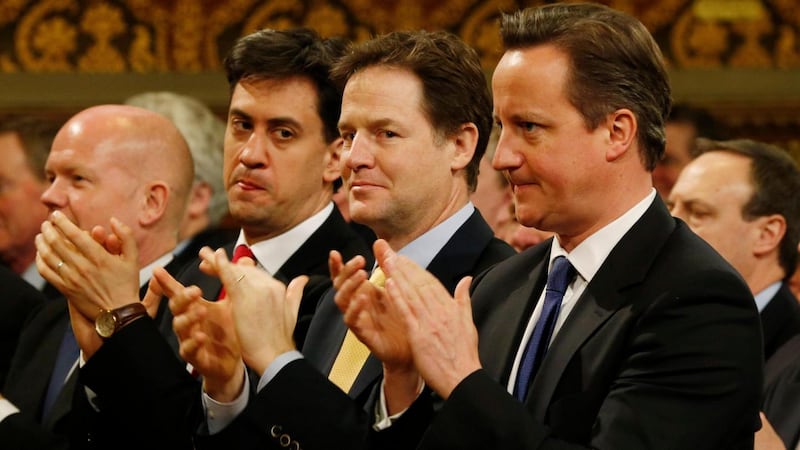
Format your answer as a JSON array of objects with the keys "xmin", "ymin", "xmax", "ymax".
[{"xmin": 500, "ymin": 3, "xmax": 672, "ymax": 170}]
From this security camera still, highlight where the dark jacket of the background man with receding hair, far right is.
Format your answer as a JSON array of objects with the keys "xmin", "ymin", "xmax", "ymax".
[{"xmin": 761, "ymin": 283, "xmax": 800, "ymax": 361}]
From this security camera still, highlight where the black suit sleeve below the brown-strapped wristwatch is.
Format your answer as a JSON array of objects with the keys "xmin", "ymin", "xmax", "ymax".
[{"xmin": 73, "ymin": 318, "xmax": 201, "ymax": 450}]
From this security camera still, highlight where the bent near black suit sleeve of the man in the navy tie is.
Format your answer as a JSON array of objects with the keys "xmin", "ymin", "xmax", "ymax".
[{"xmin": 420, "ymin": 270, "xmax": 761, "ymax": 450}]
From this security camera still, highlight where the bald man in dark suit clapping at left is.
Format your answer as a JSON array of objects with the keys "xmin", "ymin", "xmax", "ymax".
[{"xmin": 0, "ymin": 105, "xmax": 192, "ymax": 448}]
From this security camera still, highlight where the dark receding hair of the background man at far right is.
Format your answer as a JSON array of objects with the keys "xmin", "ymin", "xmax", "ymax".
[{"xmin": 696, "ymin": 138, "xmax": 800, "ymax": 277}]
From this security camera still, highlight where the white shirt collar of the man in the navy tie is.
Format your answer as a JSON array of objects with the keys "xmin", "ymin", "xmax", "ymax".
[{"xmin": 547, "ymin": 189, "xmax": 656, "ymax": 282}]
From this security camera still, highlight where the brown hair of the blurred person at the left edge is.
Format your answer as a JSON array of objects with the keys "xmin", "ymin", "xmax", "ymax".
[{"xmin": 0, "ymin": 115, "xmax": 63, "ymax": 180}]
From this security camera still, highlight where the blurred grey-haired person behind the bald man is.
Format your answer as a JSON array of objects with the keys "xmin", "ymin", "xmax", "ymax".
[{"xmin": 125, "ymin": 91, "xmax": 239, "ymax": 265}]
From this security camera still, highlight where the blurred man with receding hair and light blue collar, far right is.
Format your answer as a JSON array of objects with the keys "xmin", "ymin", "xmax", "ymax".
[{"xmin": 669, "ymin": 139, "xmax": 800, "ymax": 361}]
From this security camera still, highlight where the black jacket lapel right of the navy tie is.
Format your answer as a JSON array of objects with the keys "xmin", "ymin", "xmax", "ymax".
[{"xmin": 527, "ymin": 198, "xmax": 675, "ymax": 420}]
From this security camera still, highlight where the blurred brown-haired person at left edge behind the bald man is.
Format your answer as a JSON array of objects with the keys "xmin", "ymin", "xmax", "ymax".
[{"xmin": 0, "ymin": 116, "xmax": 61, "ymax": 297}]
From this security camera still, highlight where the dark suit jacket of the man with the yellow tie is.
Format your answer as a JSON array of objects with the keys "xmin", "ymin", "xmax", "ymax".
[{"xmin": 197, "ymin": 211, "xmax": 515, "ymax": 450}]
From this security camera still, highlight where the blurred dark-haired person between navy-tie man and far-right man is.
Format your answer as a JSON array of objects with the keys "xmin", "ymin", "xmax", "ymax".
[{"xmin": 653, "ymin": 104, "xmax": 727, "ymax": 200}]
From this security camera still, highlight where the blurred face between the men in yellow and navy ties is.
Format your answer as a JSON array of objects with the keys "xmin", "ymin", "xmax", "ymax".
[{"xmin": 470, "ymin": 127, "xmax": 552, "ymax": 252}]
